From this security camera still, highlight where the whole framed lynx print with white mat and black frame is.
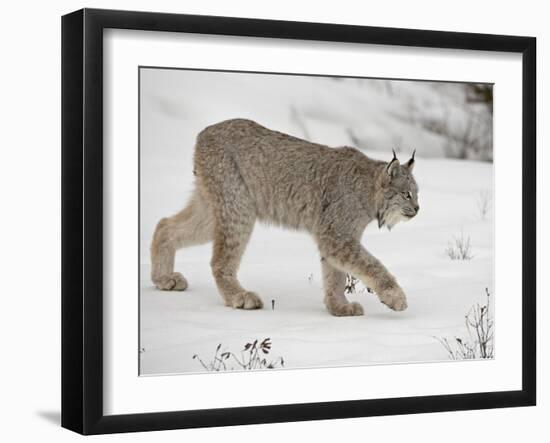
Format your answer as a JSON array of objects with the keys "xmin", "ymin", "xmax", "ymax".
[{"xmin": 62, "ymin": 9, "xmax": 536, "ymax": 434}]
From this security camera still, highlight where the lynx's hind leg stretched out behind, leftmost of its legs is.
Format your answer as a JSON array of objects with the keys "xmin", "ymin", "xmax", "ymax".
[{"xmin": 151, "ymin": 191, "xmax": 214, "ymax": 291}]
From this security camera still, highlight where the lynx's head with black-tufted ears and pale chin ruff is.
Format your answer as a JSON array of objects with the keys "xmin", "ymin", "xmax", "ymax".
[{"xmin": 378, "ymin": 151, "xmax": 420, "ymax": 229}]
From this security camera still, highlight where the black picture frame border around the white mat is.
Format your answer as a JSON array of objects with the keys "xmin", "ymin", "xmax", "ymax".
[{"xmin": 61, "ymin": 9, "xmax": 536, "ymax": 434}]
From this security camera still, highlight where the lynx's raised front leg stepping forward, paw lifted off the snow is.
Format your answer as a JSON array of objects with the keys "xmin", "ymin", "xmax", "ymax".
[{"xmin": 319, "ymin": 235, "xmax": 407, "ymax": 311}]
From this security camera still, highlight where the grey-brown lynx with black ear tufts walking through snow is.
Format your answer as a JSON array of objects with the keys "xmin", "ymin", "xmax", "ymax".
[{"xmin": 151, "ymin": 119, "xmax": 419, "ymax": 316}]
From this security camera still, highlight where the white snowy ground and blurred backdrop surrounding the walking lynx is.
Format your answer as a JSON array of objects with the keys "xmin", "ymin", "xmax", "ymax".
[{"xmin": 140, "ymin": 69, "xmax": 493, "ymax": 374}]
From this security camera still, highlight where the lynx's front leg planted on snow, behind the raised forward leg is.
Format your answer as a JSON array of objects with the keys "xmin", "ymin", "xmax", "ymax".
[{"xmin": 321, "ymin": 258, "xmax": 364, "ymax": 317}]
